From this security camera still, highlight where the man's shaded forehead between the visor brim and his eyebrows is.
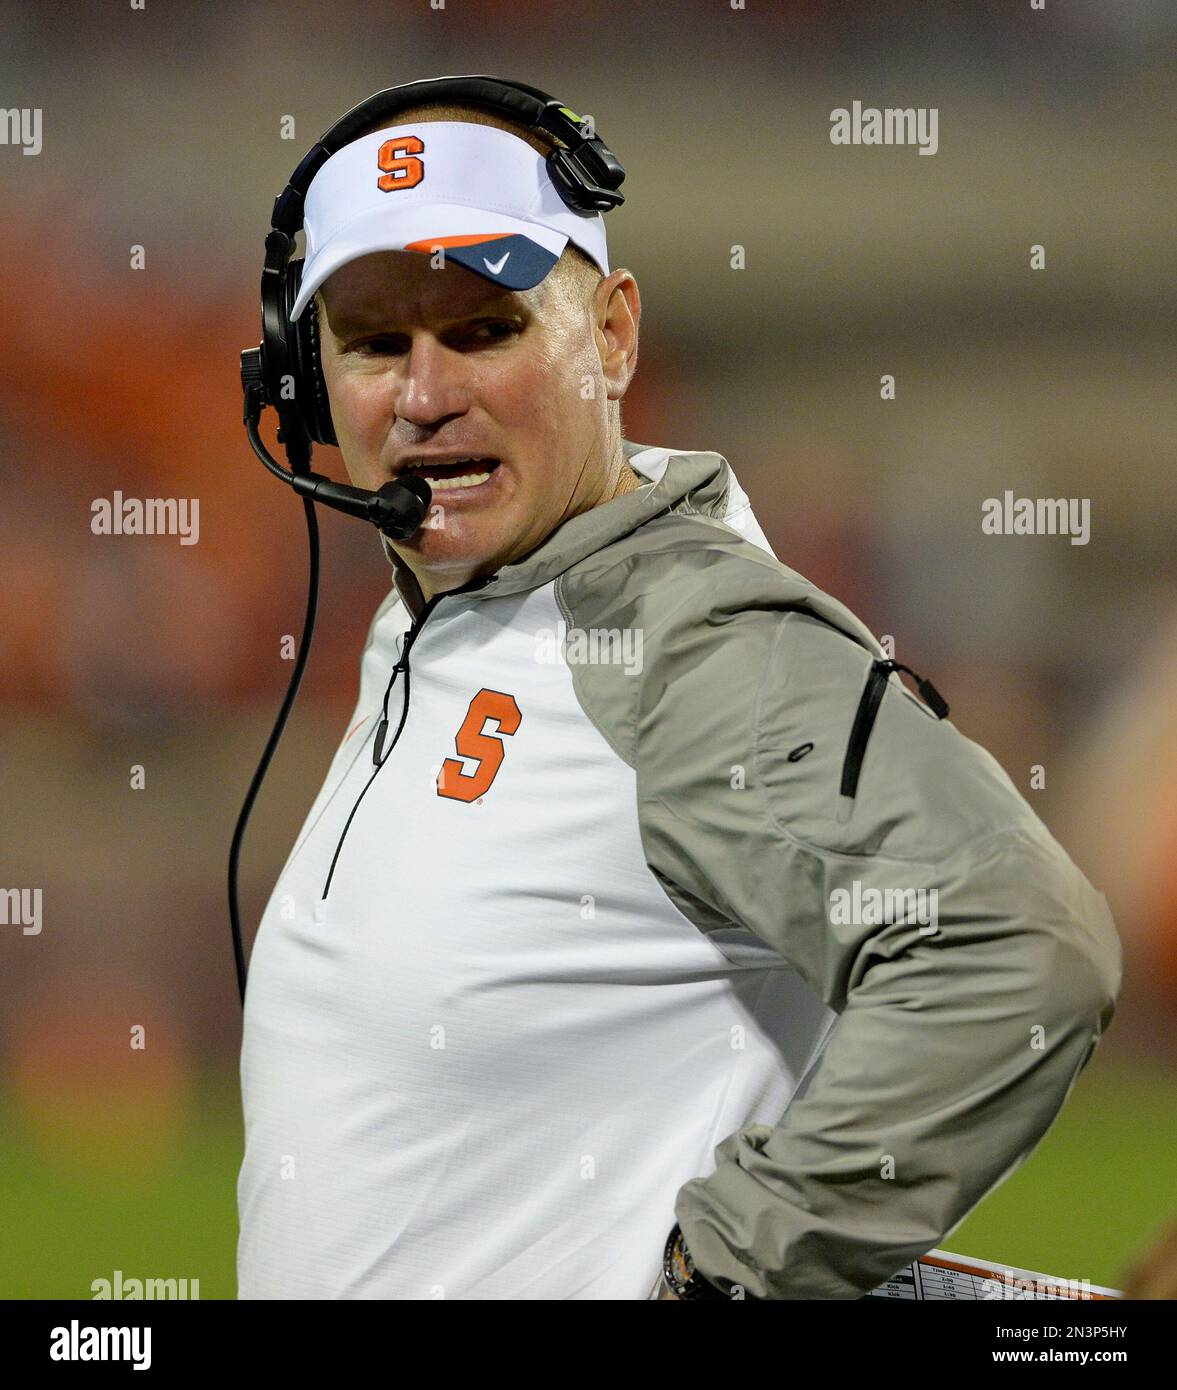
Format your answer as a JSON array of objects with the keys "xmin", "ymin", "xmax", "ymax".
[{"xmin": 312, "ymin": 252, "xmax": 542, "ymax": 327}]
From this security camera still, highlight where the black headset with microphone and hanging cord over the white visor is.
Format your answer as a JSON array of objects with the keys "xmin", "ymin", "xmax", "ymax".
[{"xmin": 229, "ymin": 75, "xmax": 636, "ymax": 1005}]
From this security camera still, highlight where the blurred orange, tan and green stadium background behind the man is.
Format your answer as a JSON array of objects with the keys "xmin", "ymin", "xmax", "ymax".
[{"xmin": 0, "ymin": 0, "xmax": 1177, "ymax": 1298}]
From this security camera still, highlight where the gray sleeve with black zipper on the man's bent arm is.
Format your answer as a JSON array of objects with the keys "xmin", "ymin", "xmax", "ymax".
[{"xmin": 634, "ymin": 596, "xmax": 1120, "ymax": 1298}]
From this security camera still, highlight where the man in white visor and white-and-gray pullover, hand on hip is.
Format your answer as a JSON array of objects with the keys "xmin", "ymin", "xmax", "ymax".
[{"xmin": 238, "ymin": 92, "xmax": 1120, "ymax": 1300}]
